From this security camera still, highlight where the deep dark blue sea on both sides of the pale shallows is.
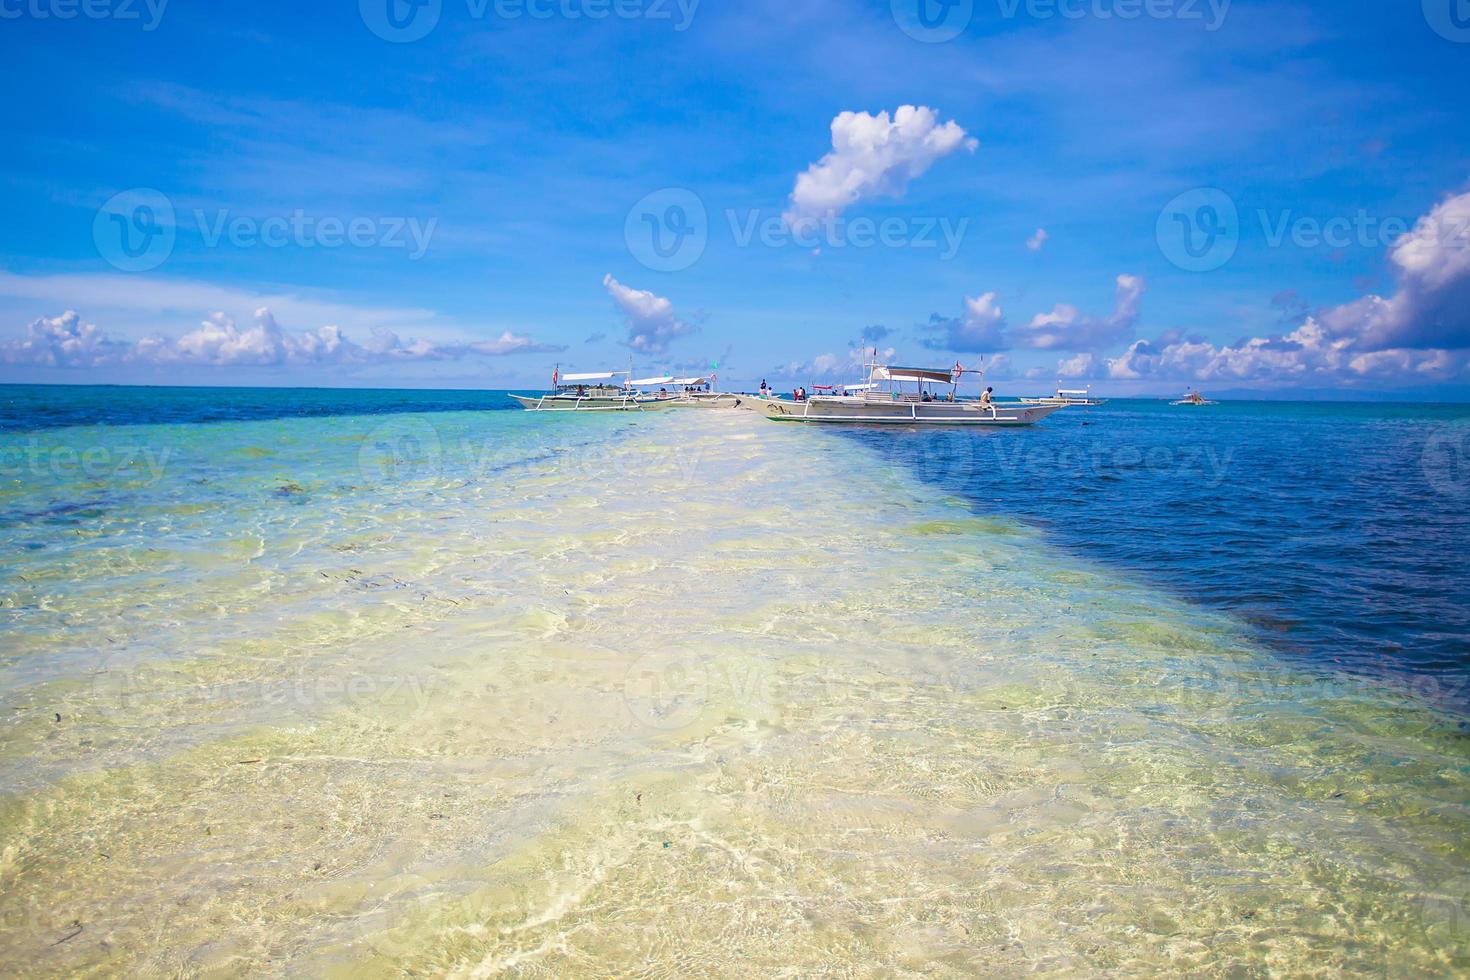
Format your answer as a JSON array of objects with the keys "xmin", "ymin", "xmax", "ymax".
[{"xmin": 0, "ymin": 385, "xmax": 1470, "ymax": 702}]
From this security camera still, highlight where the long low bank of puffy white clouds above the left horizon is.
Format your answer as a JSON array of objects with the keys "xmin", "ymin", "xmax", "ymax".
[{"xmin": 0, "ymin": 307, "xmax": 564, "ymax": 367}]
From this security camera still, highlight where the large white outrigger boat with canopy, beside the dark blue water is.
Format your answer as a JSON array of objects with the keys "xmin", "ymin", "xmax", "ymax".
[{"xmin": 741, "ymin": 358, "xmax": 1063, "ymax": 426}]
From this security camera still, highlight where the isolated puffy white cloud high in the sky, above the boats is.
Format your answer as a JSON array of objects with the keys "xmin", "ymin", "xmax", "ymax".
[{"xmin": 784, "ymin": 106, "xmax": 979, "ymax": 228}]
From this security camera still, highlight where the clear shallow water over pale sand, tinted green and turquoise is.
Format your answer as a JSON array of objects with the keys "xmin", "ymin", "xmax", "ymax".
[{"xmin": 0, "ymin": 411, "xmax": 1470, "ymax": 976}]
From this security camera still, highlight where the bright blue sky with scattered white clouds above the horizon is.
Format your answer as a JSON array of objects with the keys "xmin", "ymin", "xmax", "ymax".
[{"xmin": 0, "ymin": 0, "xmax": 1470, "ymax": 397}]
